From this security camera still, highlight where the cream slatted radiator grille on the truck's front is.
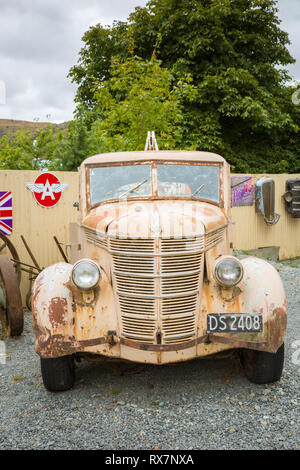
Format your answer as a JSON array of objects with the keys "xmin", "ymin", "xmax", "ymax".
[{"xmin": 109, "ymin": 227, "xmax": 225, "ymax": 345}]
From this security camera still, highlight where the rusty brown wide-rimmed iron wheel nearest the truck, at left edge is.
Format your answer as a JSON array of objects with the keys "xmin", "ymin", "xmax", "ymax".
[{"xmin": 0, "ymin": 255, "xmax": 24, "ymax": 336}]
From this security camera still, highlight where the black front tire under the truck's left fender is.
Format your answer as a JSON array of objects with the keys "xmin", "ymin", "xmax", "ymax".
[{"xmin": 41, "ymin": 356, "xmax": 75, "ymax": 392}]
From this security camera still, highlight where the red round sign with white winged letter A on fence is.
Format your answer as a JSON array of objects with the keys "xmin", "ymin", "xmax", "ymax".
[{"xmin": 25, "ymin": 171, "xmax": 69, "ymax": 207}]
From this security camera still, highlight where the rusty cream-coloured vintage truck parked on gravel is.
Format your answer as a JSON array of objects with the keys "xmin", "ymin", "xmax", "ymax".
[{"xmin": 32, "ymin": 151, "xmax": 287, "ymax": 391}]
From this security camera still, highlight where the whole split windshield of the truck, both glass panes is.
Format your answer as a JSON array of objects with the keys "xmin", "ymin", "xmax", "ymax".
[{"xmin": 89, "ymin": 163, "xmax": 220, "ymax": 205}]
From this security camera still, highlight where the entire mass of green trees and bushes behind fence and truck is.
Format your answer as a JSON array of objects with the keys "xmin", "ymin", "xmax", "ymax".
[{"xmin": 0, "ymin": 0, "xmax": 300, "ymax": 173}]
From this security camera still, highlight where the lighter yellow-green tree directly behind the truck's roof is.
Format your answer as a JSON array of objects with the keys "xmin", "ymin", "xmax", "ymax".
[{"xmin": 85, "ymin": 56, "xmax": 197, "ymax": 153}]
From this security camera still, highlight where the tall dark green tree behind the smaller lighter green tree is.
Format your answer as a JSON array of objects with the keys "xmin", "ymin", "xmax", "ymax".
[{"xmin": 70, "ymin": 0, "xmax": 300, "ymax": 172}]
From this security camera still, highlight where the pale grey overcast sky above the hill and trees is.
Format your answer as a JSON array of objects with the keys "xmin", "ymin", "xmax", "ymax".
[{"xmin": 0, "ymin": 0, "xmax": 300, "ymax": 122}]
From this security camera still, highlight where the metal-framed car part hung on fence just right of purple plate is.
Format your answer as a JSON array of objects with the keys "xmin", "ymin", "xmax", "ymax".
[{"xmin": 255, "ymin": 177, "xmax": 280, "ymax": 225}]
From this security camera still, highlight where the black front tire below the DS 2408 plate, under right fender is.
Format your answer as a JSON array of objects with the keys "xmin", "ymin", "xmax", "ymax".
[{"xmin": 242, "ymin": 344, "xmax": 284, "ymax": 384}]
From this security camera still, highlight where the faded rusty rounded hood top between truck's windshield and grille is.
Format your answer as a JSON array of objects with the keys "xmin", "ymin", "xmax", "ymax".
[{"xmin": 82, "ymin": 200, "xmax": 227, "ymax": 238}]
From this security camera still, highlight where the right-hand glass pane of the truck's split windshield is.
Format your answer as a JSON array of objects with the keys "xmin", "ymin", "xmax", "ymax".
[{"xmin": 157, "ymin": 164, "xmax": 220, "ymax": 202}]
